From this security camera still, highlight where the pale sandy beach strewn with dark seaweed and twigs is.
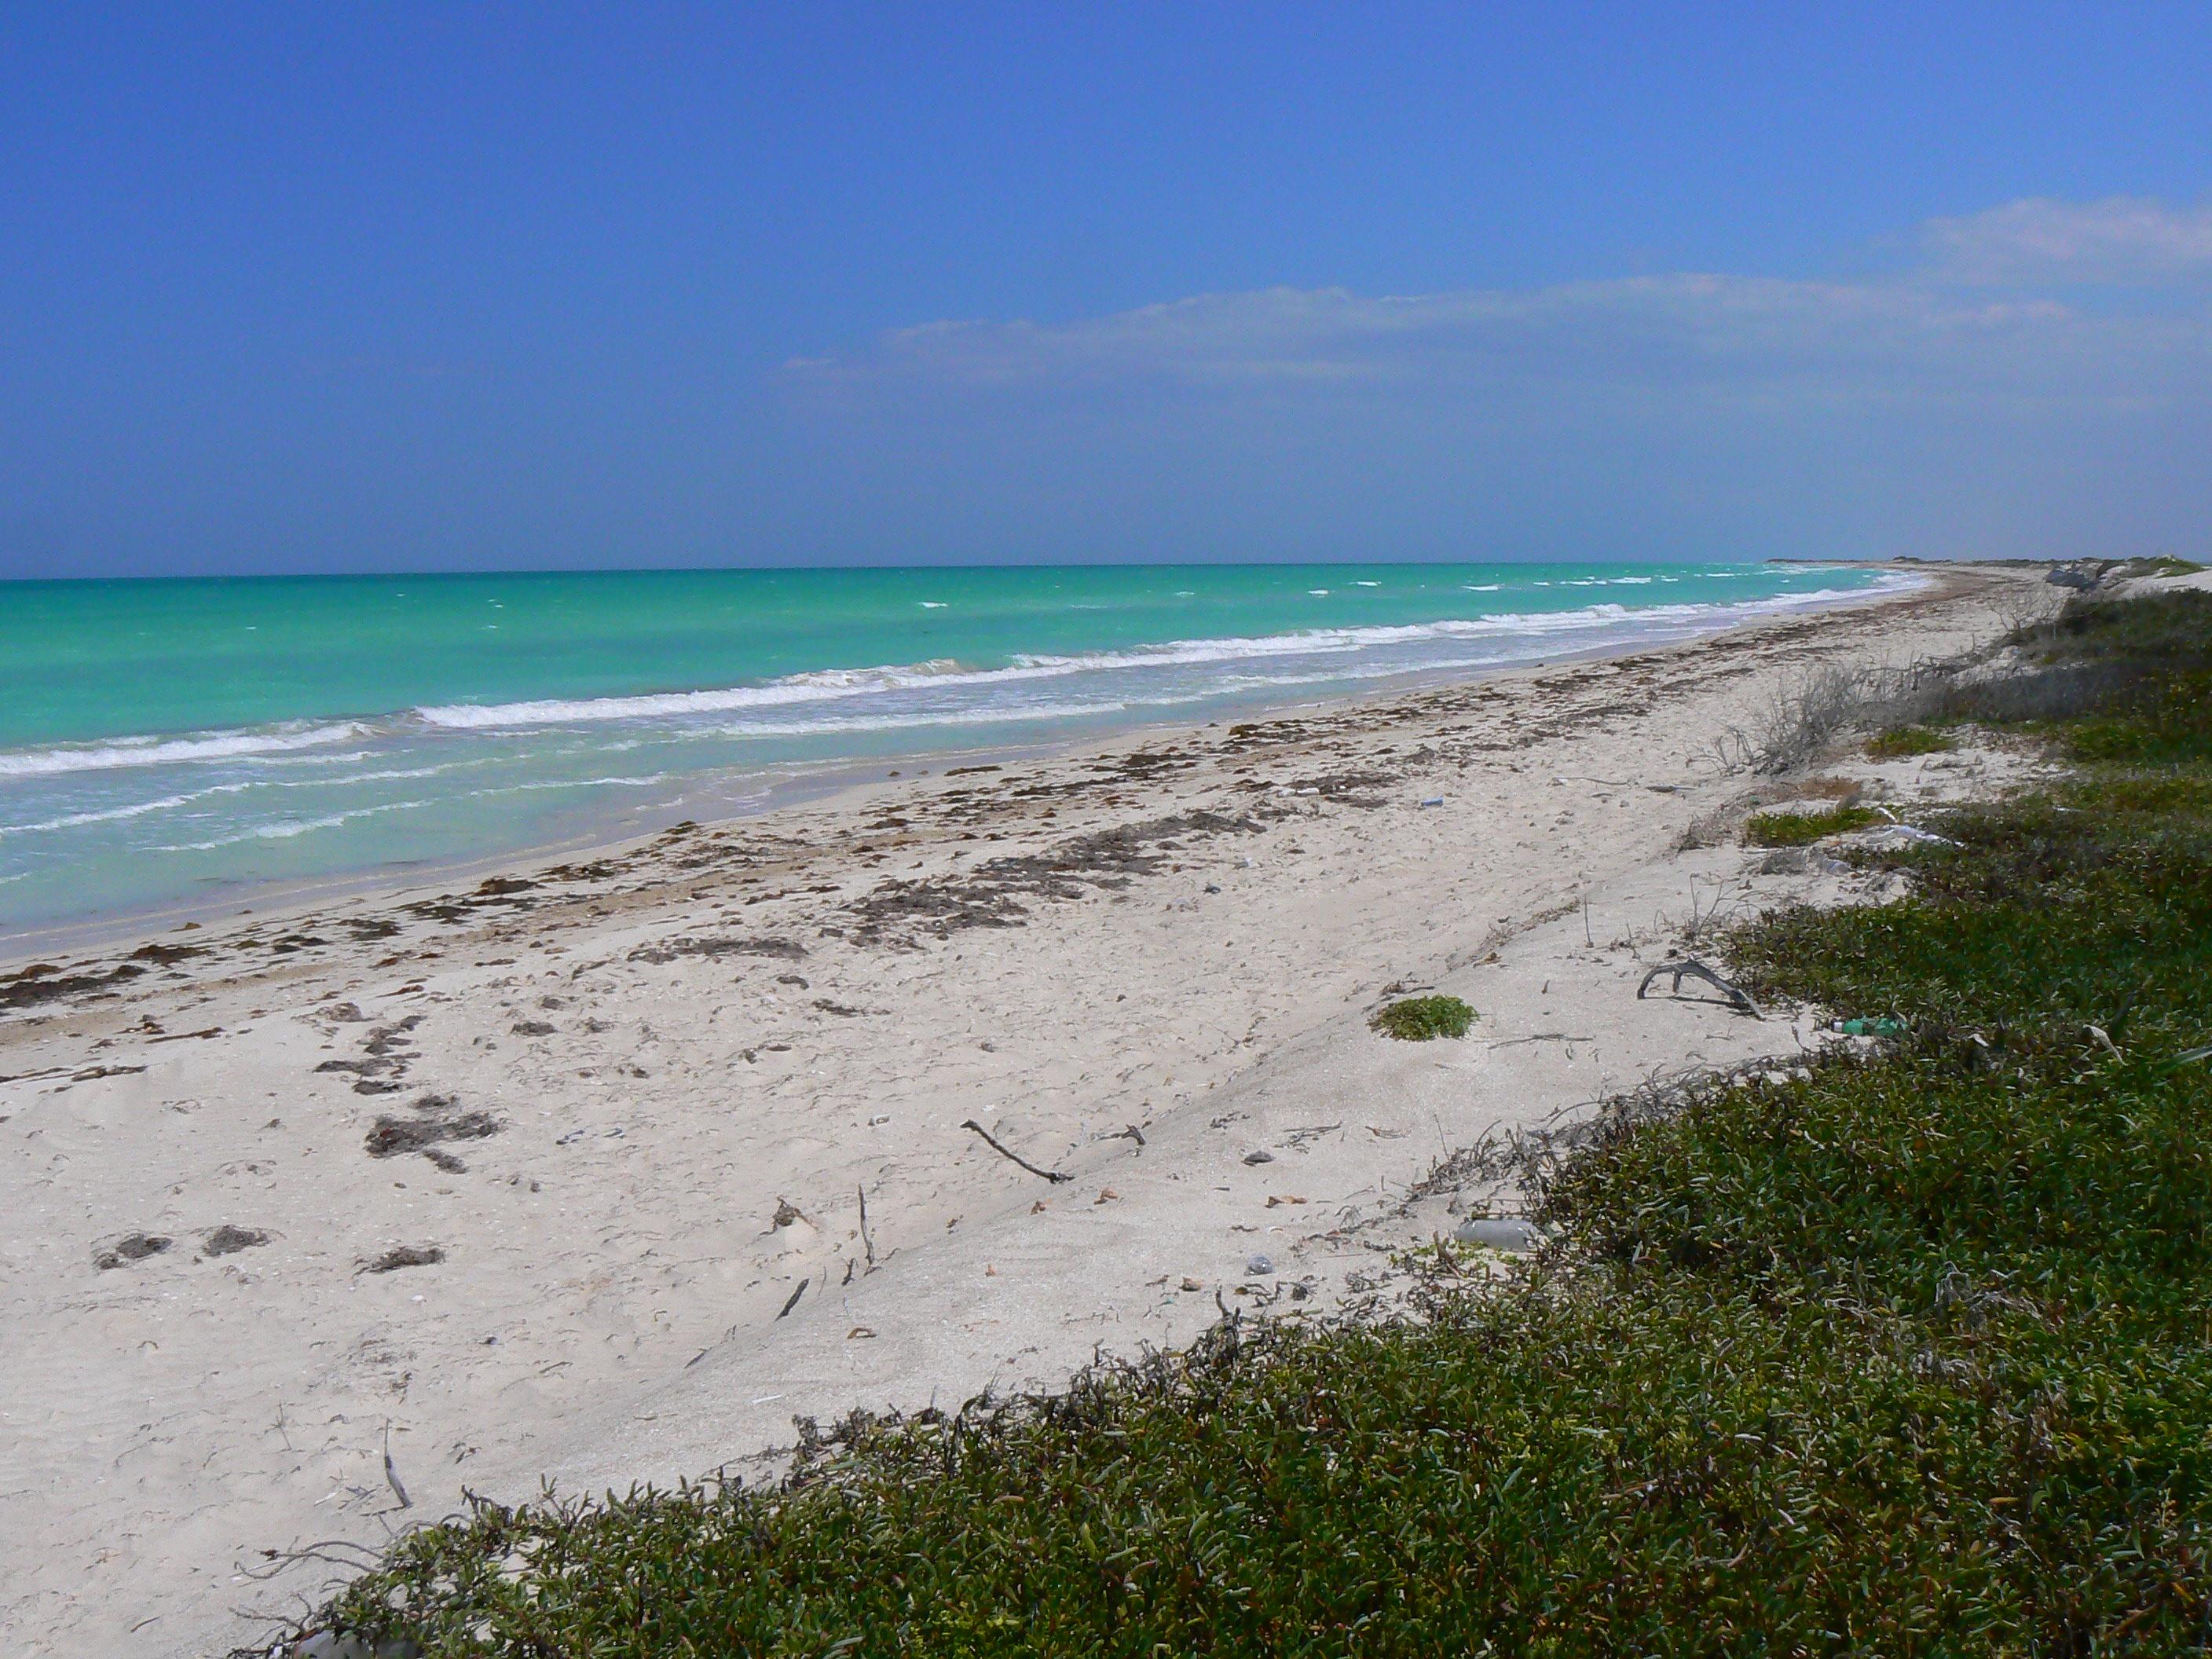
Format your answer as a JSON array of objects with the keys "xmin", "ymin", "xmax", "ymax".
[{"xmin": 0, "ymin": 566, "xmax": 2042, "ymax": 1657}]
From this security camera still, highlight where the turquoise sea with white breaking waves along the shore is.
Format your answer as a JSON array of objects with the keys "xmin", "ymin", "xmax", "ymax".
[{"xmin": 0, "ymin": 564, "xmax": 1909, "ymax": 938}]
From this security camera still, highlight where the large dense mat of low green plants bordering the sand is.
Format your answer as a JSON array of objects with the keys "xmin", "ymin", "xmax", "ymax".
[{"xmin": 307, "ymin": 595, "xmax": 2212, "ymax": 1659}]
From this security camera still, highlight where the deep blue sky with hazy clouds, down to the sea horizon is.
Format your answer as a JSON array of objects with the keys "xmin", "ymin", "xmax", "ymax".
[{"xmin": 0, "ymin": 0, "xmax": 2212, "ymax": 575}]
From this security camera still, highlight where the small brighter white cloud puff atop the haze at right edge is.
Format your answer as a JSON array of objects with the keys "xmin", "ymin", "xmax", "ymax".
[{"xmin": 1925, "ymin": 197, "xmax": 2212, "ymax": 285}]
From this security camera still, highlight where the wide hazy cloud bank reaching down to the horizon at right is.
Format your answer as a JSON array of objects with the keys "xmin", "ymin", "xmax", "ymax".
[{"xmin": 783, "ymin": 201, "xmax": 2212, "ymax": 558}]
